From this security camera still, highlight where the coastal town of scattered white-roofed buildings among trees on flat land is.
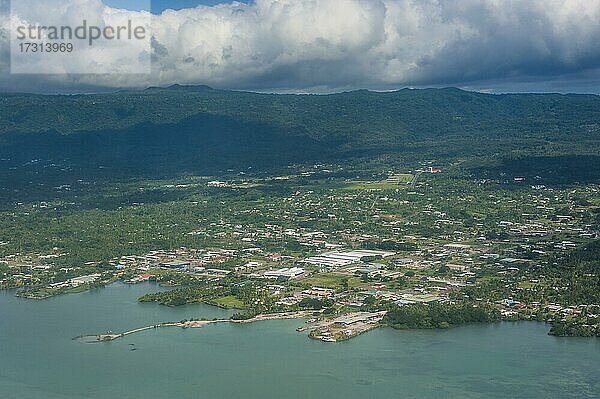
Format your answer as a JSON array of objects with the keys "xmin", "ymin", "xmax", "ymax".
[{"xmin": 0, "ymin": 165, "xmax": 600, "ymax": 342}]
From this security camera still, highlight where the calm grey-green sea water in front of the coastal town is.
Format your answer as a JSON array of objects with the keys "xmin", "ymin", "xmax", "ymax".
[{"xmin": 0, "ymin": 284, "xmax": 600, "ymax": 399}]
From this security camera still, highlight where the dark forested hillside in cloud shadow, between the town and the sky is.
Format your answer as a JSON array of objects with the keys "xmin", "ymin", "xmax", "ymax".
[{"xmin": 0, "ymin": 86, "xmax": 600, "ymax": 181}]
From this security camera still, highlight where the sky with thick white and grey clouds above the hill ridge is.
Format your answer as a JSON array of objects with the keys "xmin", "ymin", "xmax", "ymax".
[{"xmin": 0, "ymin": 0, "xmax": 600, "ymax": 94}]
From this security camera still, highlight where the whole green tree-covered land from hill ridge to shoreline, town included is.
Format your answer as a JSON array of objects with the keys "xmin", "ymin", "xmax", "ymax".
[{"xmin": 0, "ymin": 87, "xmax": 600, "ymax": 336}]
